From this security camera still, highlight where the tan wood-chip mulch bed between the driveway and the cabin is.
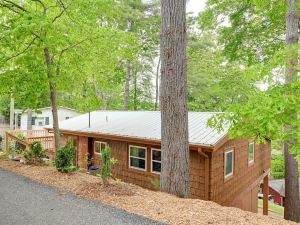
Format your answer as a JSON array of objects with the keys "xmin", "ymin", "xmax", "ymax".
[{"xmin": 0, "ymin": 159, "xmax": 295, "ymax": 225}]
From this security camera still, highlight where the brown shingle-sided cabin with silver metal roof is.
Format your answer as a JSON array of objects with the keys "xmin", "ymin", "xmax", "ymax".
[{"xmin": 45, "ymin": 111, "xmax": 271, "ymax": 214}]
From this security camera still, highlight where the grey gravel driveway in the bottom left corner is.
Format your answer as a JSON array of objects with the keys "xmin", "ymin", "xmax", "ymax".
[{"xmin": 0, "ymin": 169, "xmax": 164, "ymax": 225}]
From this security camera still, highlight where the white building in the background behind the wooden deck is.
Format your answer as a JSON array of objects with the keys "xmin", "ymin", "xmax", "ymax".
[{"xmin": 20, "ymin": 107, "xmax": 81, "ymax": 130}]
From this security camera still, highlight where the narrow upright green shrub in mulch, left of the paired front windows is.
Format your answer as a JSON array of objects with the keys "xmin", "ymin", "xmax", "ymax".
[{"xmin": 101, "ymin": 146, "xmax": 117, "ymax": 185}]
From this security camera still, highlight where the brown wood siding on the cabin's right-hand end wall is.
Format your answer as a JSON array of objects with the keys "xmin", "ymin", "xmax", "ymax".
[{"xmin": 209, "ymin": 140, "xmax": 271, "ymax": 212}]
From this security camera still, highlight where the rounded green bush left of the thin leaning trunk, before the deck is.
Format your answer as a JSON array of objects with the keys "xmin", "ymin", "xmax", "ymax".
[{"xmin": 24, "ymin": 141, "xmax": 46, "ymax": 165}]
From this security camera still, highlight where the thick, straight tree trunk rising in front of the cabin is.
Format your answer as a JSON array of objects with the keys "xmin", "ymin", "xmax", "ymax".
[{"xmin": 160, "ymin": 0, "xmax": 190, "ymax": 198}]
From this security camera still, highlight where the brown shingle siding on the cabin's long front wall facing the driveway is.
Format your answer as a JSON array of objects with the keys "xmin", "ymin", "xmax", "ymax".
[{"xmin": 65, "ymin": 136, "xmax": 205, "ymax": 199}]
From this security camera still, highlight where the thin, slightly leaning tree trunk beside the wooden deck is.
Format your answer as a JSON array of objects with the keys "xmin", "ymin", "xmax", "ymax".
[{"xmin": 44, "ymin": 47, "xmax": 60, "ymax": 151}]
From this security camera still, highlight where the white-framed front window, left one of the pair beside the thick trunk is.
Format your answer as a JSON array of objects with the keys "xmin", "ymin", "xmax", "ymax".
[{"xmin": 129, "ymin": 145, "xmax": 147, "ymax": 170}]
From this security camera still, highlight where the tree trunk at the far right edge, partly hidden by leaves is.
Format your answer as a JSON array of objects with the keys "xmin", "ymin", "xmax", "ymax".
[{"xmin": 284, "ymin": 0, "xmax": 300, "ymax": 222}]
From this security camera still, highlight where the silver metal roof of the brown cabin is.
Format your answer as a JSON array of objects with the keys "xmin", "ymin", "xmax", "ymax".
[{"xmin": 59, "ymin": 111, "xmax": 227, "ymax": 146}]
